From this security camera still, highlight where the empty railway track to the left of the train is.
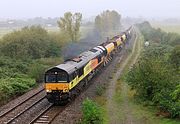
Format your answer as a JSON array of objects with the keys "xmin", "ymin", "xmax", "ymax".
[{"xmin": 0, "ymin": 89, "xmax": 45, "ymax": 124}]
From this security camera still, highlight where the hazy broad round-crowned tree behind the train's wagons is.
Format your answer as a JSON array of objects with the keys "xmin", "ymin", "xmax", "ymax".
[{"xmin": 95, "ymin": 10, "xmax": 121, "ymax": 36}]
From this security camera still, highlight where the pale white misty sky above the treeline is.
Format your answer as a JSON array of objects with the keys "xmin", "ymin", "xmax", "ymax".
[{"xmin": 0, "ymin": 0, "xmax": 180, "ymax": 18}]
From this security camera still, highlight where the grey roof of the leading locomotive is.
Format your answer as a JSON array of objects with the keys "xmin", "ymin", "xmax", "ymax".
[{"xmin": 49, "ymin": 48, "xmax": 102, "ymax": 74}]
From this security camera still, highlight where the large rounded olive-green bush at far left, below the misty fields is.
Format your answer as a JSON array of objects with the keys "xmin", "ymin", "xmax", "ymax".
[{"xmin": 1, "ymin": 26, "xmax": 60, "ymax": 59}]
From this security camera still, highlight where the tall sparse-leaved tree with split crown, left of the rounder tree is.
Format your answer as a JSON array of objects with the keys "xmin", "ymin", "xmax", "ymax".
[{"xmin": 57, "ymin": 12, "xmax": 82, "ymax": 41}]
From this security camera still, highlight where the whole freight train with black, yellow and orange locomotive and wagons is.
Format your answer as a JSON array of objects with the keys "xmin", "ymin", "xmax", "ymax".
[{"xmin": 45, "ymin": 27, "xmax": 132, "ymax": 104}]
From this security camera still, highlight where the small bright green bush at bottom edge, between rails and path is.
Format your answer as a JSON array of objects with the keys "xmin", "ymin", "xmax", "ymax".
[{"xmin": 82, "ymin": 99, "xmax": 103, "ymax": 124}]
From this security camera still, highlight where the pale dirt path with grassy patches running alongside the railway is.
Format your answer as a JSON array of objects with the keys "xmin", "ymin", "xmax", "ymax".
[{"xmin": 107, "ymin": 27, "xmax": 142, "ymax": 124}]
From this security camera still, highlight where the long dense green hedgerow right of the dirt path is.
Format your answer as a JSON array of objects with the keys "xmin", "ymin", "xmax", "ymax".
[{"xmin": 126, "ymin": 22, "xmax": 180, "ymax": 118}]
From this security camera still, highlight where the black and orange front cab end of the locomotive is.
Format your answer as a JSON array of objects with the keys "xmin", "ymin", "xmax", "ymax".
[{"xmin": 45, "ymin": 67, "xmax": 69, "ymax": 102}]
